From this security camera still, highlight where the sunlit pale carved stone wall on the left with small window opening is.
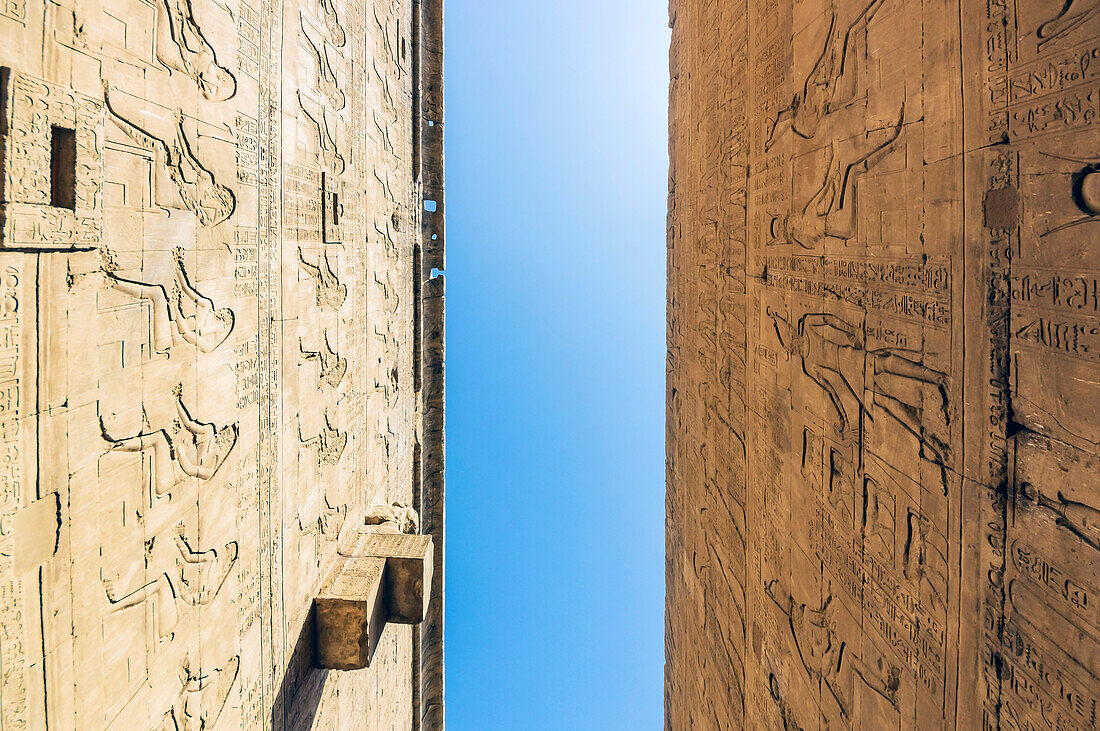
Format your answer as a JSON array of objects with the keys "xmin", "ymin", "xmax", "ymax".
[{"xmin": 0, "ymin": 0, "xmax": 443, "ymax": 730}]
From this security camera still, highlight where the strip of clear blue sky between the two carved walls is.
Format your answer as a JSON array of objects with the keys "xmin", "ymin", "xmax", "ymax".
[{"xmin": 446, "ymin": 0, "xmax": 669, "ymax": 731}]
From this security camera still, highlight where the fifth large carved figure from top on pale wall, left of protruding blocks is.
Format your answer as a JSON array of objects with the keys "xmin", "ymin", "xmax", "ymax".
[{"xmin": 102, "ymin": 524, "xmax": 239, "ymax": 645}]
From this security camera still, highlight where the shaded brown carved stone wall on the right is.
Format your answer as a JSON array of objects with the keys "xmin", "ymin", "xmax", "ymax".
[{"xmin": 666, "ymin": 0, "xmax": 1100, "ymax": 730}]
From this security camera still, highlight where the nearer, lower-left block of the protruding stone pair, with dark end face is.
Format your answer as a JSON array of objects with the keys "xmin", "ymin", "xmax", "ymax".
[{"xmin": 316, "ymin": 557, "xmax": 386, "ymax": 671}]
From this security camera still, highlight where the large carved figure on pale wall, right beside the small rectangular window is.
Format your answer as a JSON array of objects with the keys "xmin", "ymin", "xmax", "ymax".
[{"xmin": 103, "ymin": 81, "xmax": 237, "ymax": 226}]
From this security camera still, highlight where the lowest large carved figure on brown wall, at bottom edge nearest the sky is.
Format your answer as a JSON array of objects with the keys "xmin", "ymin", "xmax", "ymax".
[{"xmin": 765, "ymin": 579, "xmax": 901, "ymax": 722}]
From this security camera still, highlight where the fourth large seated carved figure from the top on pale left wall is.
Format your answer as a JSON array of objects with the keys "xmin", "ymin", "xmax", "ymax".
[{"xmin": 99, "ymin": 385, "xmax": 240, "ymax": 496}]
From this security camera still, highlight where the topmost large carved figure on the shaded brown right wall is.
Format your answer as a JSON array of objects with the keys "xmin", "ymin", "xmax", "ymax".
[{"xmin": 763, "ymin": 0, "xmax": 884, "ymax": 152}]
